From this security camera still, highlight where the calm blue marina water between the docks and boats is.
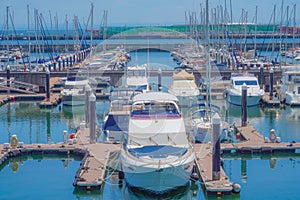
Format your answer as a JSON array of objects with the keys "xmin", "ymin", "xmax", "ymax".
[{"xmin": 0, "ymin": 52, "xmax": 300, "ymax": 199}]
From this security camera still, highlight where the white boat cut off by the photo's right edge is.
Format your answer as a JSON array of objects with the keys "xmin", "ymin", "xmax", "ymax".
[{"xmin": 279, "ymin": 66, "xmax": 300, "ymax": 106}]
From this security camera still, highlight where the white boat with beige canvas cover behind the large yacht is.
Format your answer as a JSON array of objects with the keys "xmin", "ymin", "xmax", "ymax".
[{"xmin": 168, "ymin": 70, "xmax": 199, "ymax": 97}]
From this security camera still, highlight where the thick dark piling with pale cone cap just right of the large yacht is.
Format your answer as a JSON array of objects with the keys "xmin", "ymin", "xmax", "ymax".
[{"xmin": 212, "ymin": 113, "xmax": 221, "ymax": 180}]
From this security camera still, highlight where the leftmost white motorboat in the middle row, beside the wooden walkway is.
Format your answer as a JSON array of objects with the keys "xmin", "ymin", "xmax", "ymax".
[{"xmin": 61, "ymin": 76, "xmax": 89, "ymax": 106}]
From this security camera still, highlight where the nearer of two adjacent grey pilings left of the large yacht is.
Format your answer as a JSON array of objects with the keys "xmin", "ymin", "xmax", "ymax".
[{"xmin": 89, "ymin": 93, "xmax": 96, "ymax": 144}]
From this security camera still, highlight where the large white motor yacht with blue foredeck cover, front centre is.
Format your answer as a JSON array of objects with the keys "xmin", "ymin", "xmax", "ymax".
[{"xmin": 121, "ymin": 92, "xmax": 195, "ymax": 193}]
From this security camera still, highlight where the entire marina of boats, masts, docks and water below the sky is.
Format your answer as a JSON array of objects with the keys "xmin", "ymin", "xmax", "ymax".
[{"xmin": 0, "ymin": 0, "xmax": 300, "ymax": 199}]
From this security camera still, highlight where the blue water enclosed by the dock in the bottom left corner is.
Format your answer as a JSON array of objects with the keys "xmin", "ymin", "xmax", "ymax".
[{"xmin": 0, "ymin": 155, "xmax": 80, "ymax": 200}]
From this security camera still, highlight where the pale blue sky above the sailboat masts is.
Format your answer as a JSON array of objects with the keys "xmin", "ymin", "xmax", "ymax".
[{"xmin": 0, "ymin": 0, "xmax": 300, "ymax": 28}]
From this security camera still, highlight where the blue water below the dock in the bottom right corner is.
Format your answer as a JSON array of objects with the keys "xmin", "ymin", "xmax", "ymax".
[{"xmin": 222, "ymin": 157, "xmax": 300, "ymax": 199}]
